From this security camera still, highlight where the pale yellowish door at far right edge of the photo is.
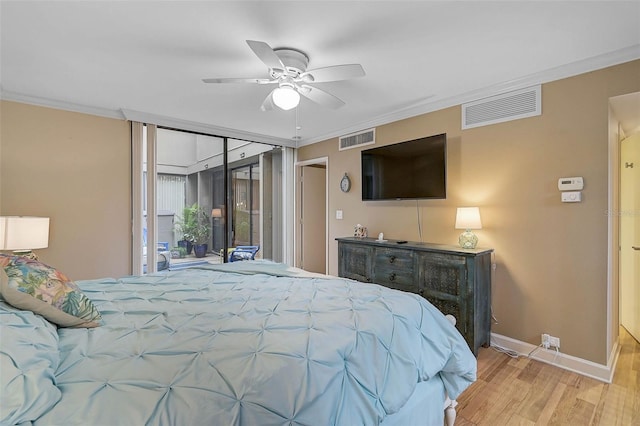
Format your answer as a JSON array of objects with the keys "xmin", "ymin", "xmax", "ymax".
[{"xmin": 619, "ymin": 134, "xmax": 640, "ymax": 342}]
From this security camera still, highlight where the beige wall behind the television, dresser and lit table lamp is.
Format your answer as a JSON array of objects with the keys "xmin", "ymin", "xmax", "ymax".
[{"xmin": 298, "ymin": 61, "xmax": 640, "ymax": 364}]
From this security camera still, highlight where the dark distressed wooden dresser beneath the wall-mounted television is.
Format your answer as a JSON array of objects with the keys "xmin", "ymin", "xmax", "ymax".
[{"xmin": 337, "ymin": 237, "xmax": 493, "ymax": 356}]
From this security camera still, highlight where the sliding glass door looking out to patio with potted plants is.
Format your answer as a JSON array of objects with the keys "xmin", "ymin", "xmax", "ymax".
[{"xmin": 133, "ymin": 123, "xmax": 283, "ymax": 273}]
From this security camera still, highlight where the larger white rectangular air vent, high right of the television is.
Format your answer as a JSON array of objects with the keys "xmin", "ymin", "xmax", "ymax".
[{"xmin": 462, "ymin": 85, "xmax": 542, "ymax": 129}]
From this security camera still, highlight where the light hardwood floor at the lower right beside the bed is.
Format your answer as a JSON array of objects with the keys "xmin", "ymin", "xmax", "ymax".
[{"xmin": 456, "ymin": 329, "xmax": 640, "ymax": 426}]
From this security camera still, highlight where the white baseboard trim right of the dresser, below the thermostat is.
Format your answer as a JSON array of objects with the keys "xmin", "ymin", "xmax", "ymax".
[{"xmin": 491, "ymin": 333, "xmax": 620, "ymax": 383}]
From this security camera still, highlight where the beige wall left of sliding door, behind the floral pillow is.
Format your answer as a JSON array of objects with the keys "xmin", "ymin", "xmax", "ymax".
[{"xmin": 0, "ymin": 101, "xmax": 131, "ymax": 280}]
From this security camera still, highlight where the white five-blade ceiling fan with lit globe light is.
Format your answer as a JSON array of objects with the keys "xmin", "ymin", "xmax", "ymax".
[{"xmin": 202, "ymin": 40, "xmax": 365, "ymax": 111}]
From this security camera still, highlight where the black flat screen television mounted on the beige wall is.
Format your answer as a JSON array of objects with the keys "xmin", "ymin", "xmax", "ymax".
[{"xmin": 361, "ymin": 133, "xmax": 447, "ymax": 201}]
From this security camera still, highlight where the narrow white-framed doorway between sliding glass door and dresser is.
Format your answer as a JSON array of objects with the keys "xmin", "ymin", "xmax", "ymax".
[{"xmin": 296, "ymin": 158, "xmax": 328, "ymax": 274}]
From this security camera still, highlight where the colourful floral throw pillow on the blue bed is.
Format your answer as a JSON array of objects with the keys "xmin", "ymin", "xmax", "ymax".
[{"xmin": 0, "ymin": 254, "xmax": 102, "ymax": 327}]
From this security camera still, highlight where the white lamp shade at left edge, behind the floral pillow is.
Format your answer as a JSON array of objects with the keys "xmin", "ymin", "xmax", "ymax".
[{"xmin": 0, "ymin": 216, "xmax": 49, "ymax": 250}]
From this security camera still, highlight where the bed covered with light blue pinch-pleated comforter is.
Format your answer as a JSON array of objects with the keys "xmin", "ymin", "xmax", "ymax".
[{"xmin": 0, "ymin": 259, "xmax": 476, "ymax": 426}]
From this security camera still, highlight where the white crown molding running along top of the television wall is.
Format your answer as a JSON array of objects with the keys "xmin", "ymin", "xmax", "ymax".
[{"xmin": 298, "ymin": 43, "xmax": 640, "ymax": 147}]
